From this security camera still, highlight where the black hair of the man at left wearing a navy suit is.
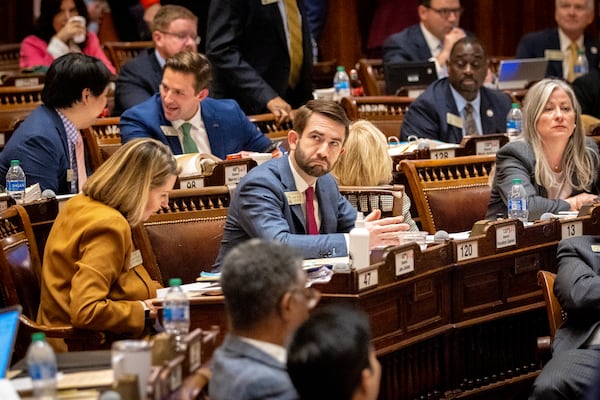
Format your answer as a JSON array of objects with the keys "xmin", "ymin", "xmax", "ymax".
[{"xmin": 42, "ymin": 53, "xmax": 111, "ymax": 108}]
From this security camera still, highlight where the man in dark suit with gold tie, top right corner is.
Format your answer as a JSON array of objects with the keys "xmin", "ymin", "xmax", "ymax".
[{"xmin": 516, "ymin": 0, "xmax": 600, "ymax": 82}]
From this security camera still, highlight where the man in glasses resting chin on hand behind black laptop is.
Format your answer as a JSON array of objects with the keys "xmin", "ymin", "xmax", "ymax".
[{"xmin": 383, "ymin": 0, "xmax": 466, "ymax": 78}]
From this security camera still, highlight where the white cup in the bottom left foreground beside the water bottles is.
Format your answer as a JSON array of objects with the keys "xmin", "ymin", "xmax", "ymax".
[{"xmin": 111, "ymin": 340, "xmax": 152, "ymax": 399}]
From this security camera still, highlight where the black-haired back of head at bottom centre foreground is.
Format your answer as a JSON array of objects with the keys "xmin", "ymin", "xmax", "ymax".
[{"xmin": 287, "ymin": 305, "xmax": 379, "ymax": 400}]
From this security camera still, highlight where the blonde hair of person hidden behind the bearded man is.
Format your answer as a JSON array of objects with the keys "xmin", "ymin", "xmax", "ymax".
[{"xmin": 331, "ymin": 120, "xmax": 392, "ymax": 186}]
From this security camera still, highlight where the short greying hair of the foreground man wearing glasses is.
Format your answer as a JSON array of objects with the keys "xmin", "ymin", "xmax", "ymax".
[{"xmin": 221, "ymin": 239, "xmax": 302, "ymax": 331}]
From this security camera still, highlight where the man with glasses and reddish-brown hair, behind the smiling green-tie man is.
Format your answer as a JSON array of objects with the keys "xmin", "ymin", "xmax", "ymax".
[{"xmin": 114, "ymin": 6, "xmax": 200, "ymax": 116}]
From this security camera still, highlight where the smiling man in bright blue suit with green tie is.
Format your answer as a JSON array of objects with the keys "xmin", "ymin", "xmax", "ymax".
[{"xmin": 120, "ymin": 51, "xmax": 280, "ymax": 159}]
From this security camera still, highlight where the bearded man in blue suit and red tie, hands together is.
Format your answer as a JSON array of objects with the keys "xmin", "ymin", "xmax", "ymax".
[{"xmin": 214, "ymin": 100, "xmax": 409, "ymax": 270}]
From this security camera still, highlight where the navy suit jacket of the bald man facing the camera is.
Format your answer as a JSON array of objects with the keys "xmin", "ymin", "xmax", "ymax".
[{"xmin": 400, "ymin": 78, "xmax": 511, "ymax": 143}]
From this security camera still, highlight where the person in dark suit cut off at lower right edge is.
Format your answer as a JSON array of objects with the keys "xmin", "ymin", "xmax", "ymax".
[{"xmin": 529, "ymin": 236, "xmax": 600, "ymax": 400}]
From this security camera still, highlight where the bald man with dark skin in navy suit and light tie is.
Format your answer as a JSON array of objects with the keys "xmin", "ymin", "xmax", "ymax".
[{"xmin": 401, "ymin": 36, "xmax": 511, "ymax": 143}]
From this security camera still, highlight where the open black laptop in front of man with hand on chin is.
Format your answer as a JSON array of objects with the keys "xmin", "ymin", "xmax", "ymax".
[{"xmin": 383, "ymin": 61, "xmax": 437, "ymax": 97}]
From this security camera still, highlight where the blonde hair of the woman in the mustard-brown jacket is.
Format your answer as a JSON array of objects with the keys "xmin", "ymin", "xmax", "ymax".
[{"xmin": 82, "ymin": 139, "xmax": 179, "ymax": 226}]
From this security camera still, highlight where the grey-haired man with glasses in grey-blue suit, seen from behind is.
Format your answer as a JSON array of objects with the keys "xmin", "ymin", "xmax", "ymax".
[{"xmin": 209, "ymin": 239, "xmax": 320, "ymax": 400}]
